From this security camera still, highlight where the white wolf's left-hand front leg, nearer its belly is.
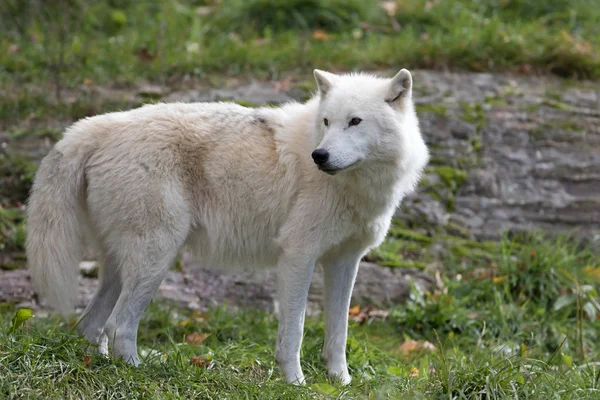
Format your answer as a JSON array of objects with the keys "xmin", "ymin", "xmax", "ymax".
[{"xmin": 275, "ymin": 255, "xmax": 315, "ymax": 385}]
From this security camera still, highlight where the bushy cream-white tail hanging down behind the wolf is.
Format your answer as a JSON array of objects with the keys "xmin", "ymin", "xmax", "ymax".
[{"xmin": 27, "ymin": 148, "xmax": 85, "ymax": 314}]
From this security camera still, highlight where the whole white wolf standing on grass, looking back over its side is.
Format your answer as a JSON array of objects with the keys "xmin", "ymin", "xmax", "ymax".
[{"xmin": 27, "ymin": 69, "xmax": 428, "ymax": 384}]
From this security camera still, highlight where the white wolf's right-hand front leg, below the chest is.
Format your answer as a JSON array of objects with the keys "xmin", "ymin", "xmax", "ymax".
[{"xmin": 322, "ymin": 249, "xmax": 363, "ymax": 385}]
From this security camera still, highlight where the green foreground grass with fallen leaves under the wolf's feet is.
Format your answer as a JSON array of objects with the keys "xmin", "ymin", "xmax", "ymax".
[{"xmin": 0, "ymin": 235, "xmax": 600, "ymax": 399}]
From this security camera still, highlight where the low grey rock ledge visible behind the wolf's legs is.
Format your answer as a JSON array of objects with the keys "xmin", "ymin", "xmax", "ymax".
[{"xmin": 0, "ymin": 253, "xmax": 434, "ymax": 315}]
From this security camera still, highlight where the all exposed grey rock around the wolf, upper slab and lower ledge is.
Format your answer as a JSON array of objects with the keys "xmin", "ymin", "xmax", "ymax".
[{"xmin": 0, "ymin": 71, "xmax": 600, "ymax": 314}]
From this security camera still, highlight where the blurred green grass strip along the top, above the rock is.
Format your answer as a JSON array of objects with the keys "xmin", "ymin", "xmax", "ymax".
[{"xmin": 0, "ymin": 0, "xmax": 600, "ymax": 87}]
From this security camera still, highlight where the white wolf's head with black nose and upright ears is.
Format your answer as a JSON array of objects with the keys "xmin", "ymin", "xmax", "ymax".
[{"xmin": 312, "ymin": 69, "xmax": 426, "ymax": 175}]
